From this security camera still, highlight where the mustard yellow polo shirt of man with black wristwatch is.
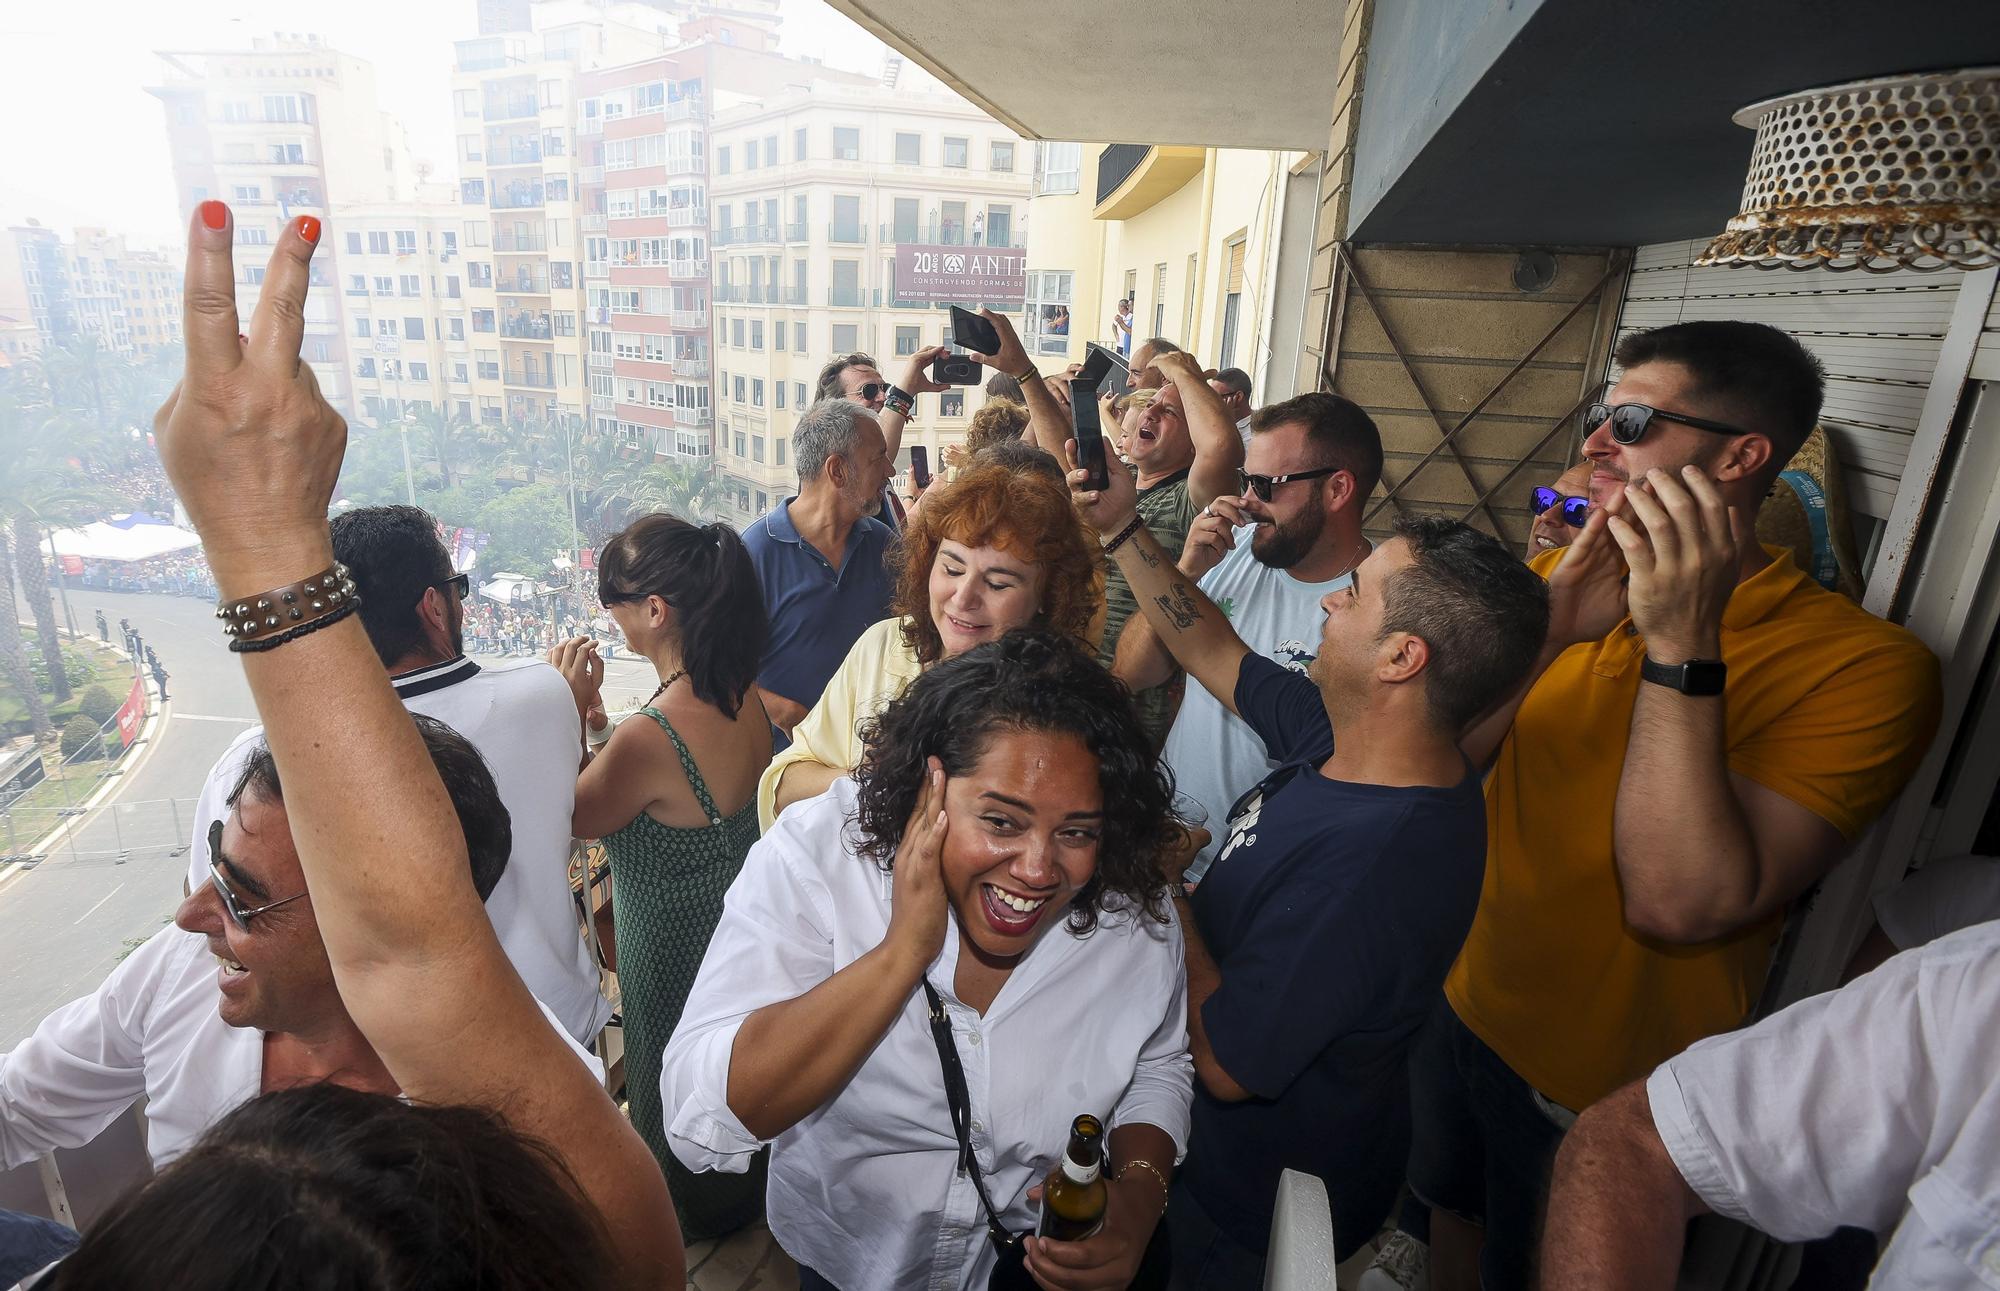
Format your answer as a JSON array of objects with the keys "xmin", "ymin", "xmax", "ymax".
[{"xmin": 1444, "ymin": 548, "xmax": 1940, "ymax": 1109}]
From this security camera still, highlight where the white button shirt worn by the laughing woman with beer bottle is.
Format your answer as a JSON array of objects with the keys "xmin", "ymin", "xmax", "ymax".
[{"xmin": 660, "ymin": 779, "xmax": 1194, "ymax": 1291}]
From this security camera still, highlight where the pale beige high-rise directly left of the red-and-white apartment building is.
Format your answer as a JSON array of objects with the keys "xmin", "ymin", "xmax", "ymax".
[{"xmin": 452, "ymin": 4, "xmax": 674, "ymax": 437}]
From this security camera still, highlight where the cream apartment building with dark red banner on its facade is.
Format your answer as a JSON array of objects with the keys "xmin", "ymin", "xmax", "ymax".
[{"xmin": 708, "ymin": 68, "xmax": 1030, "ymax": 524}]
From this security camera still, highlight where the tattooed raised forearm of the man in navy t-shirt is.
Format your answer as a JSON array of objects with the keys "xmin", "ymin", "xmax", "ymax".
[{"xmin": 1062, "ymin": 442, "xmax": 1250, "ymax": 713}]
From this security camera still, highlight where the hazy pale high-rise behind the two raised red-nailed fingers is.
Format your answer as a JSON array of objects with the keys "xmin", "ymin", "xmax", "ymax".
[{"xmin": 150, "ymin": 34, "xmax": 414, "ymax": 412}]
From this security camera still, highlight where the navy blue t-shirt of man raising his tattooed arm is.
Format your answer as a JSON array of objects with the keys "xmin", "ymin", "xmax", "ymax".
[{"xmin": 1182, "ymin": 653, "xmax": 1486, "ymax": 1257}]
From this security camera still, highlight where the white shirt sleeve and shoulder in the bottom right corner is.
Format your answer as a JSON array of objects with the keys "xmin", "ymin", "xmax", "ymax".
[{"xmin": 1646, "ymin": 923, "xmax": 2000, "ymax": 1291}]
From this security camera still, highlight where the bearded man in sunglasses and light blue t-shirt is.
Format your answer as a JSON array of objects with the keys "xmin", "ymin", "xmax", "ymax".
[{"xmin": 1112, "ymin": 394, "xmax": 1382, "ymax": 881}]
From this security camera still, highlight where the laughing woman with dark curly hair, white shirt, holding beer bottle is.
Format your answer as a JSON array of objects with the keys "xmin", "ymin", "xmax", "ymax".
[{"xmin": 660, "ymin": 628, "xmax": 1194, "ymax": 1291}]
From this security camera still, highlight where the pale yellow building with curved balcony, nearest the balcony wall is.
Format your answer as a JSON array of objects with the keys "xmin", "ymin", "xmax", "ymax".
[{"xmin": 1024, "ymin": 142, "xmax": 1318, "ymax": 404}]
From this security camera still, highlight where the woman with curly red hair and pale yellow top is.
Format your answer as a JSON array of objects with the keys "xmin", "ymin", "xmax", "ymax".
[{"xmin": 756, "ymin": 464, "xmax": 1104, "ymax": 829}]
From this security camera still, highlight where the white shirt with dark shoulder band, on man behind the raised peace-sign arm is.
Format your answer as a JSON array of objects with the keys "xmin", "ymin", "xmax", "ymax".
[{"xmin": 188, "ymin": 657, "xmax": 612, "ymax": 1043}]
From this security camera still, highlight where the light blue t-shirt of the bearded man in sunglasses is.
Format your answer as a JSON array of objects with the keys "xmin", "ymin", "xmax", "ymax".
[{"xmin": 1160, "ymin": 524, "xmax": 1354, "ymax": 881}]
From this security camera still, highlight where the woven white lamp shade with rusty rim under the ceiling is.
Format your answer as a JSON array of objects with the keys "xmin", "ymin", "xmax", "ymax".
[{"xmin": 1696, "ymin": 68, "xmax": 2000, "ymax": 274}]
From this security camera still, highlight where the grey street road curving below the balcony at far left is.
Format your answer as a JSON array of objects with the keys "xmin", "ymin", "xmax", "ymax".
[{"xmin": 0, "ymin": 590, "xmax": 656, "ymax": 1051}]
